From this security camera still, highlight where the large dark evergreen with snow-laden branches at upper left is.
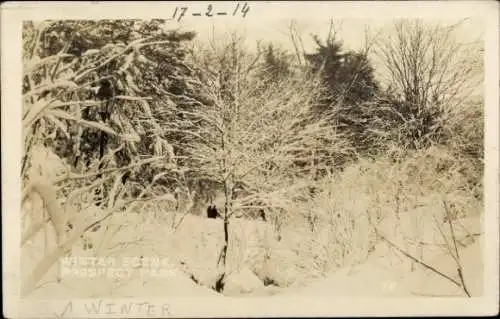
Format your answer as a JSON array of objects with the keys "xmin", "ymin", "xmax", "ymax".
[{"xmin": 24, "ymin": 19, "xmax": 206, "ymax": 198}]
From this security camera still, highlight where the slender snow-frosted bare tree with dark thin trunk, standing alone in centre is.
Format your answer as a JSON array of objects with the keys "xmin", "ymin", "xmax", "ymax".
[{"xmin": 185, "ymin": 37, "xmax": 349, "ymax": 289}]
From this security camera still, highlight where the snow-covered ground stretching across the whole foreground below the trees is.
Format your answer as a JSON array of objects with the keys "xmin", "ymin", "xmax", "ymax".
[{"xmin": 21, "ymin": 144, "xmax": 483, "ymax": 299}]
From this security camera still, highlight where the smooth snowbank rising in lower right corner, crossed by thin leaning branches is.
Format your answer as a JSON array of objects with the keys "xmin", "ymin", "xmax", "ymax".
[{"xmin": 284, "ymin": 231, "xmax": 483, "ymax": 297}]
